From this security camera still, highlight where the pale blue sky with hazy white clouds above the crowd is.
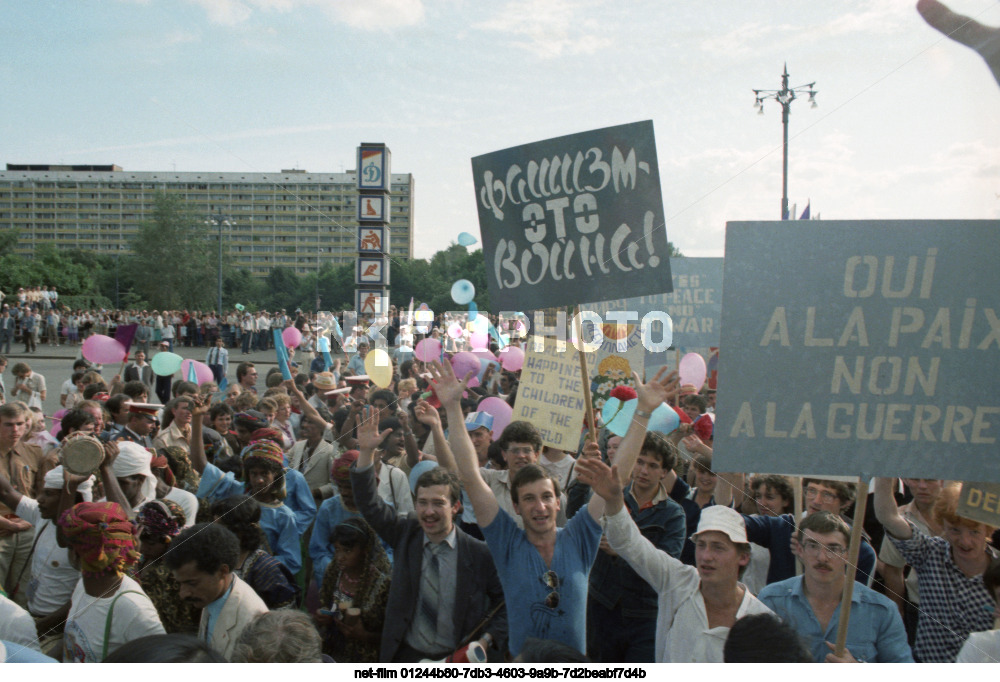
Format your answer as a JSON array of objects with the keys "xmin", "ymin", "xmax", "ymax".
[{"xmin": 0, "ymin": 0, "xmax": 1000, "ymax": 258}]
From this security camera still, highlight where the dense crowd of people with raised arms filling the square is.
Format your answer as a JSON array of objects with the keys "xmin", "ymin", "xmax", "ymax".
[{"xmin": 0, "ymin": 298, "xmax": 1000, "ymax": 663}]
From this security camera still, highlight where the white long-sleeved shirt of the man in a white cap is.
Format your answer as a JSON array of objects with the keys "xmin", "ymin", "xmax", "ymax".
[{"xmin": 605, "ymin": 507, "xmax": 771, "ymax": 663}]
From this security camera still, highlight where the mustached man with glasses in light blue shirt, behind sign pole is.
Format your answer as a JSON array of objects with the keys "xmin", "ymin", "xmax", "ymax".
[{"xmin": 759, "ymin": 511, "xmax": 913, "ymax": 663}]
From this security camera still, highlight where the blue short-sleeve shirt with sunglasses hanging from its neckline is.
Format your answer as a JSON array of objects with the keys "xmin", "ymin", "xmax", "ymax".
[{"xmin": 482, "ymin": 509, "xmax": 601, "ymax": 656}]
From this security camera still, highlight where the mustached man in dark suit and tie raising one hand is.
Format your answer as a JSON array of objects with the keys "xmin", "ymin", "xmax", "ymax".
[{"xmin": 351, "ymin": 408, "xmax": 507, "ymax": 663}]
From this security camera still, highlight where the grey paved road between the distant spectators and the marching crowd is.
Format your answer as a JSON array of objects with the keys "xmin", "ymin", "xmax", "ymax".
[{"xmin": 3, "ymin": 343, "xmax": 340, "ymax": 415}]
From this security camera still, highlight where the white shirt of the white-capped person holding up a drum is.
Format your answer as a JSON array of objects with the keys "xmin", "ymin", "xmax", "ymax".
[{"xmin": 14, "ymin": 495, "xmax": 80, "ymax": 616}]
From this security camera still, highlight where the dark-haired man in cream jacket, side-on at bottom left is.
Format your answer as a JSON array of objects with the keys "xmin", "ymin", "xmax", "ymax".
[{"xmin": 163, "ymin": 523, "xmax": 268, "ymax": 660}]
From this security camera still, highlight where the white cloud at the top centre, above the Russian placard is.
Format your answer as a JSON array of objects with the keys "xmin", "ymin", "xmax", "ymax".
[{"xmin": 473, "ymin": 0, "xmax": 612, "ymax": 58}]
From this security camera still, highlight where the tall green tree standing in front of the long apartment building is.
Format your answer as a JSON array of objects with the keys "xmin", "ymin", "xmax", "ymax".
[{"xmin": 122, "ymin": 192, "xmax": 217, "ymax": 310}]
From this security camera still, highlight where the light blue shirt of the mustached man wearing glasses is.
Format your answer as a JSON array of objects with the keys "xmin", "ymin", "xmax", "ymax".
[{"xmin": 758, "ymin": 576, "xmax": 913, "ymax": 663}]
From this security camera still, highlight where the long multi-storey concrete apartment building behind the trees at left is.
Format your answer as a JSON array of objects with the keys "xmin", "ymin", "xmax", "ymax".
[{"xmin": 0, "ymin": 164, "xmax": 414, "ymax": 277}]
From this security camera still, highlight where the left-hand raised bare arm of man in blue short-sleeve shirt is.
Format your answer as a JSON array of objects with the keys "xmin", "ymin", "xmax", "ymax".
[{"xmin": 428, "ymin": 362, "xmax": 500, "ymax": 527}]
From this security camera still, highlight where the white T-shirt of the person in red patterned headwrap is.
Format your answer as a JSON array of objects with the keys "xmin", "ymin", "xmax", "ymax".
[{"xmin": 63, "ymin": 576, "xmax": 166, "ymax": 663}]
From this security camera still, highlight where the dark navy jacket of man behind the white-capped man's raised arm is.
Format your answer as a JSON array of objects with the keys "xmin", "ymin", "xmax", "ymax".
[{"xmin": 588, "ymin": 485, "xmax": 687, "ymax": 618}]
